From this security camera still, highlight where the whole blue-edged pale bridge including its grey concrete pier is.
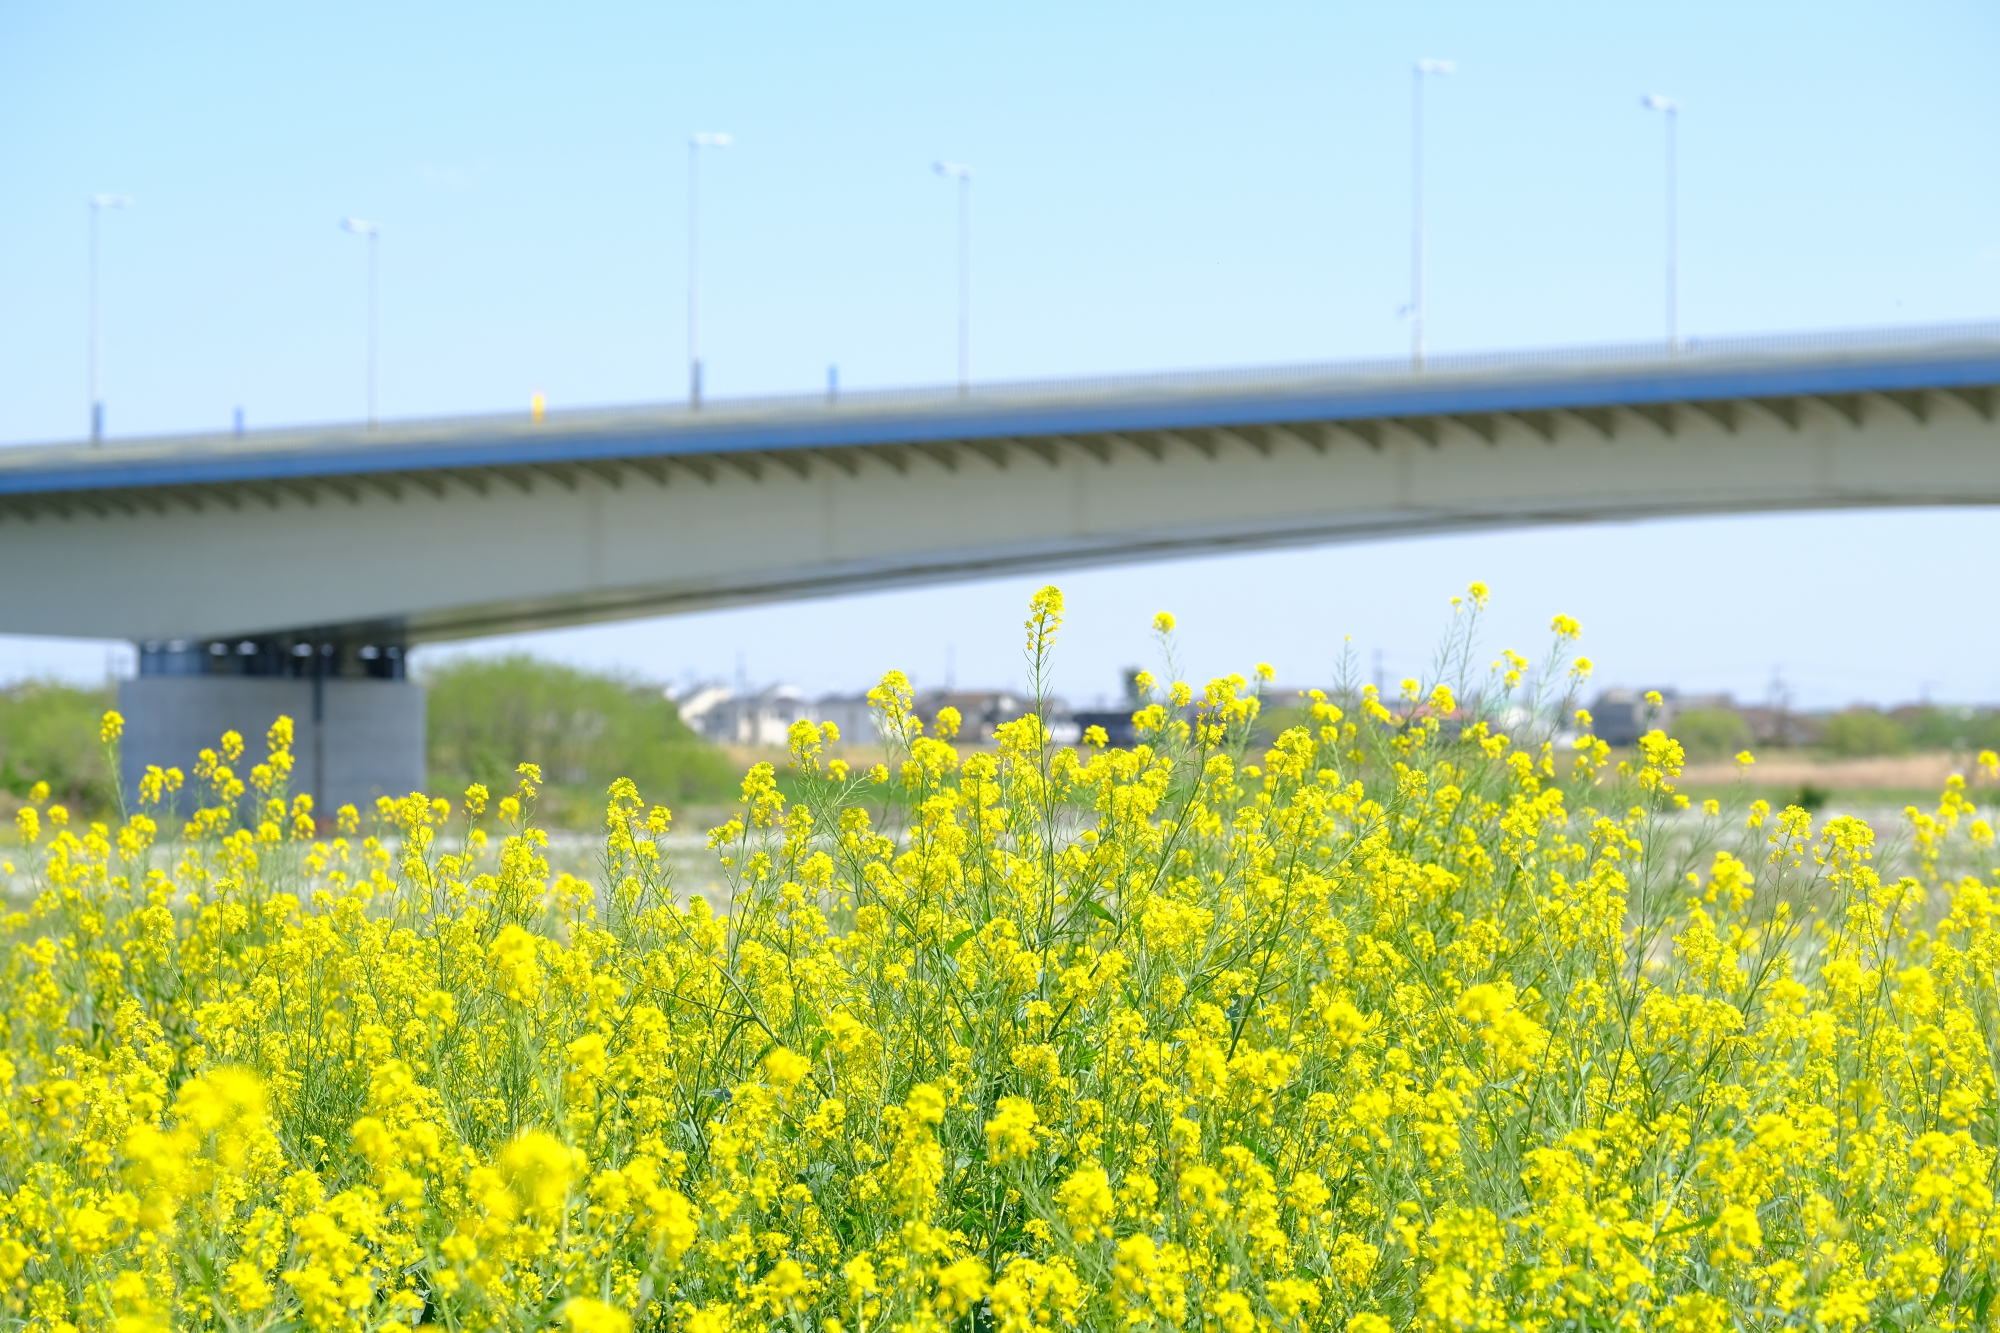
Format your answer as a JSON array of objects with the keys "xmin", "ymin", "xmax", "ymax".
[{"xmin": 0, "ymin": 324, "xmax": 2000, "ymax": 808}]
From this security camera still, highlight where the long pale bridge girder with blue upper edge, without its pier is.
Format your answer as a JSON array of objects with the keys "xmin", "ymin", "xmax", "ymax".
[{"xmin": 0, "ymin": 334, "xmax": 2000, "ymax": 642}]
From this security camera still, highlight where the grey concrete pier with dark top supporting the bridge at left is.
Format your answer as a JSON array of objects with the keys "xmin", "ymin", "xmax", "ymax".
[{"xmin": 118, "ymin": 630, "xmax": 424, "ymax": 819}]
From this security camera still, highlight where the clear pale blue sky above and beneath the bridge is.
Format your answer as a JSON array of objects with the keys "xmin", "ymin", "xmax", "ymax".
[{"xmin": 0, "ymin": 0, "xmax": 2000, "ymax": 703}]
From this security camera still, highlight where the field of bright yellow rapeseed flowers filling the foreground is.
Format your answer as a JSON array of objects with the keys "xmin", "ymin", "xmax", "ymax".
[{"xmin": 0, "ymin": 584, "xmax": 2000, "ymax": 1333}]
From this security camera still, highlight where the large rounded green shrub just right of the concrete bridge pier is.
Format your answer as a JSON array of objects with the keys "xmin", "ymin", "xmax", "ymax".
[{"xmin": 426, "ymin": 654, "xmax": 736, "ymax": 825}]
